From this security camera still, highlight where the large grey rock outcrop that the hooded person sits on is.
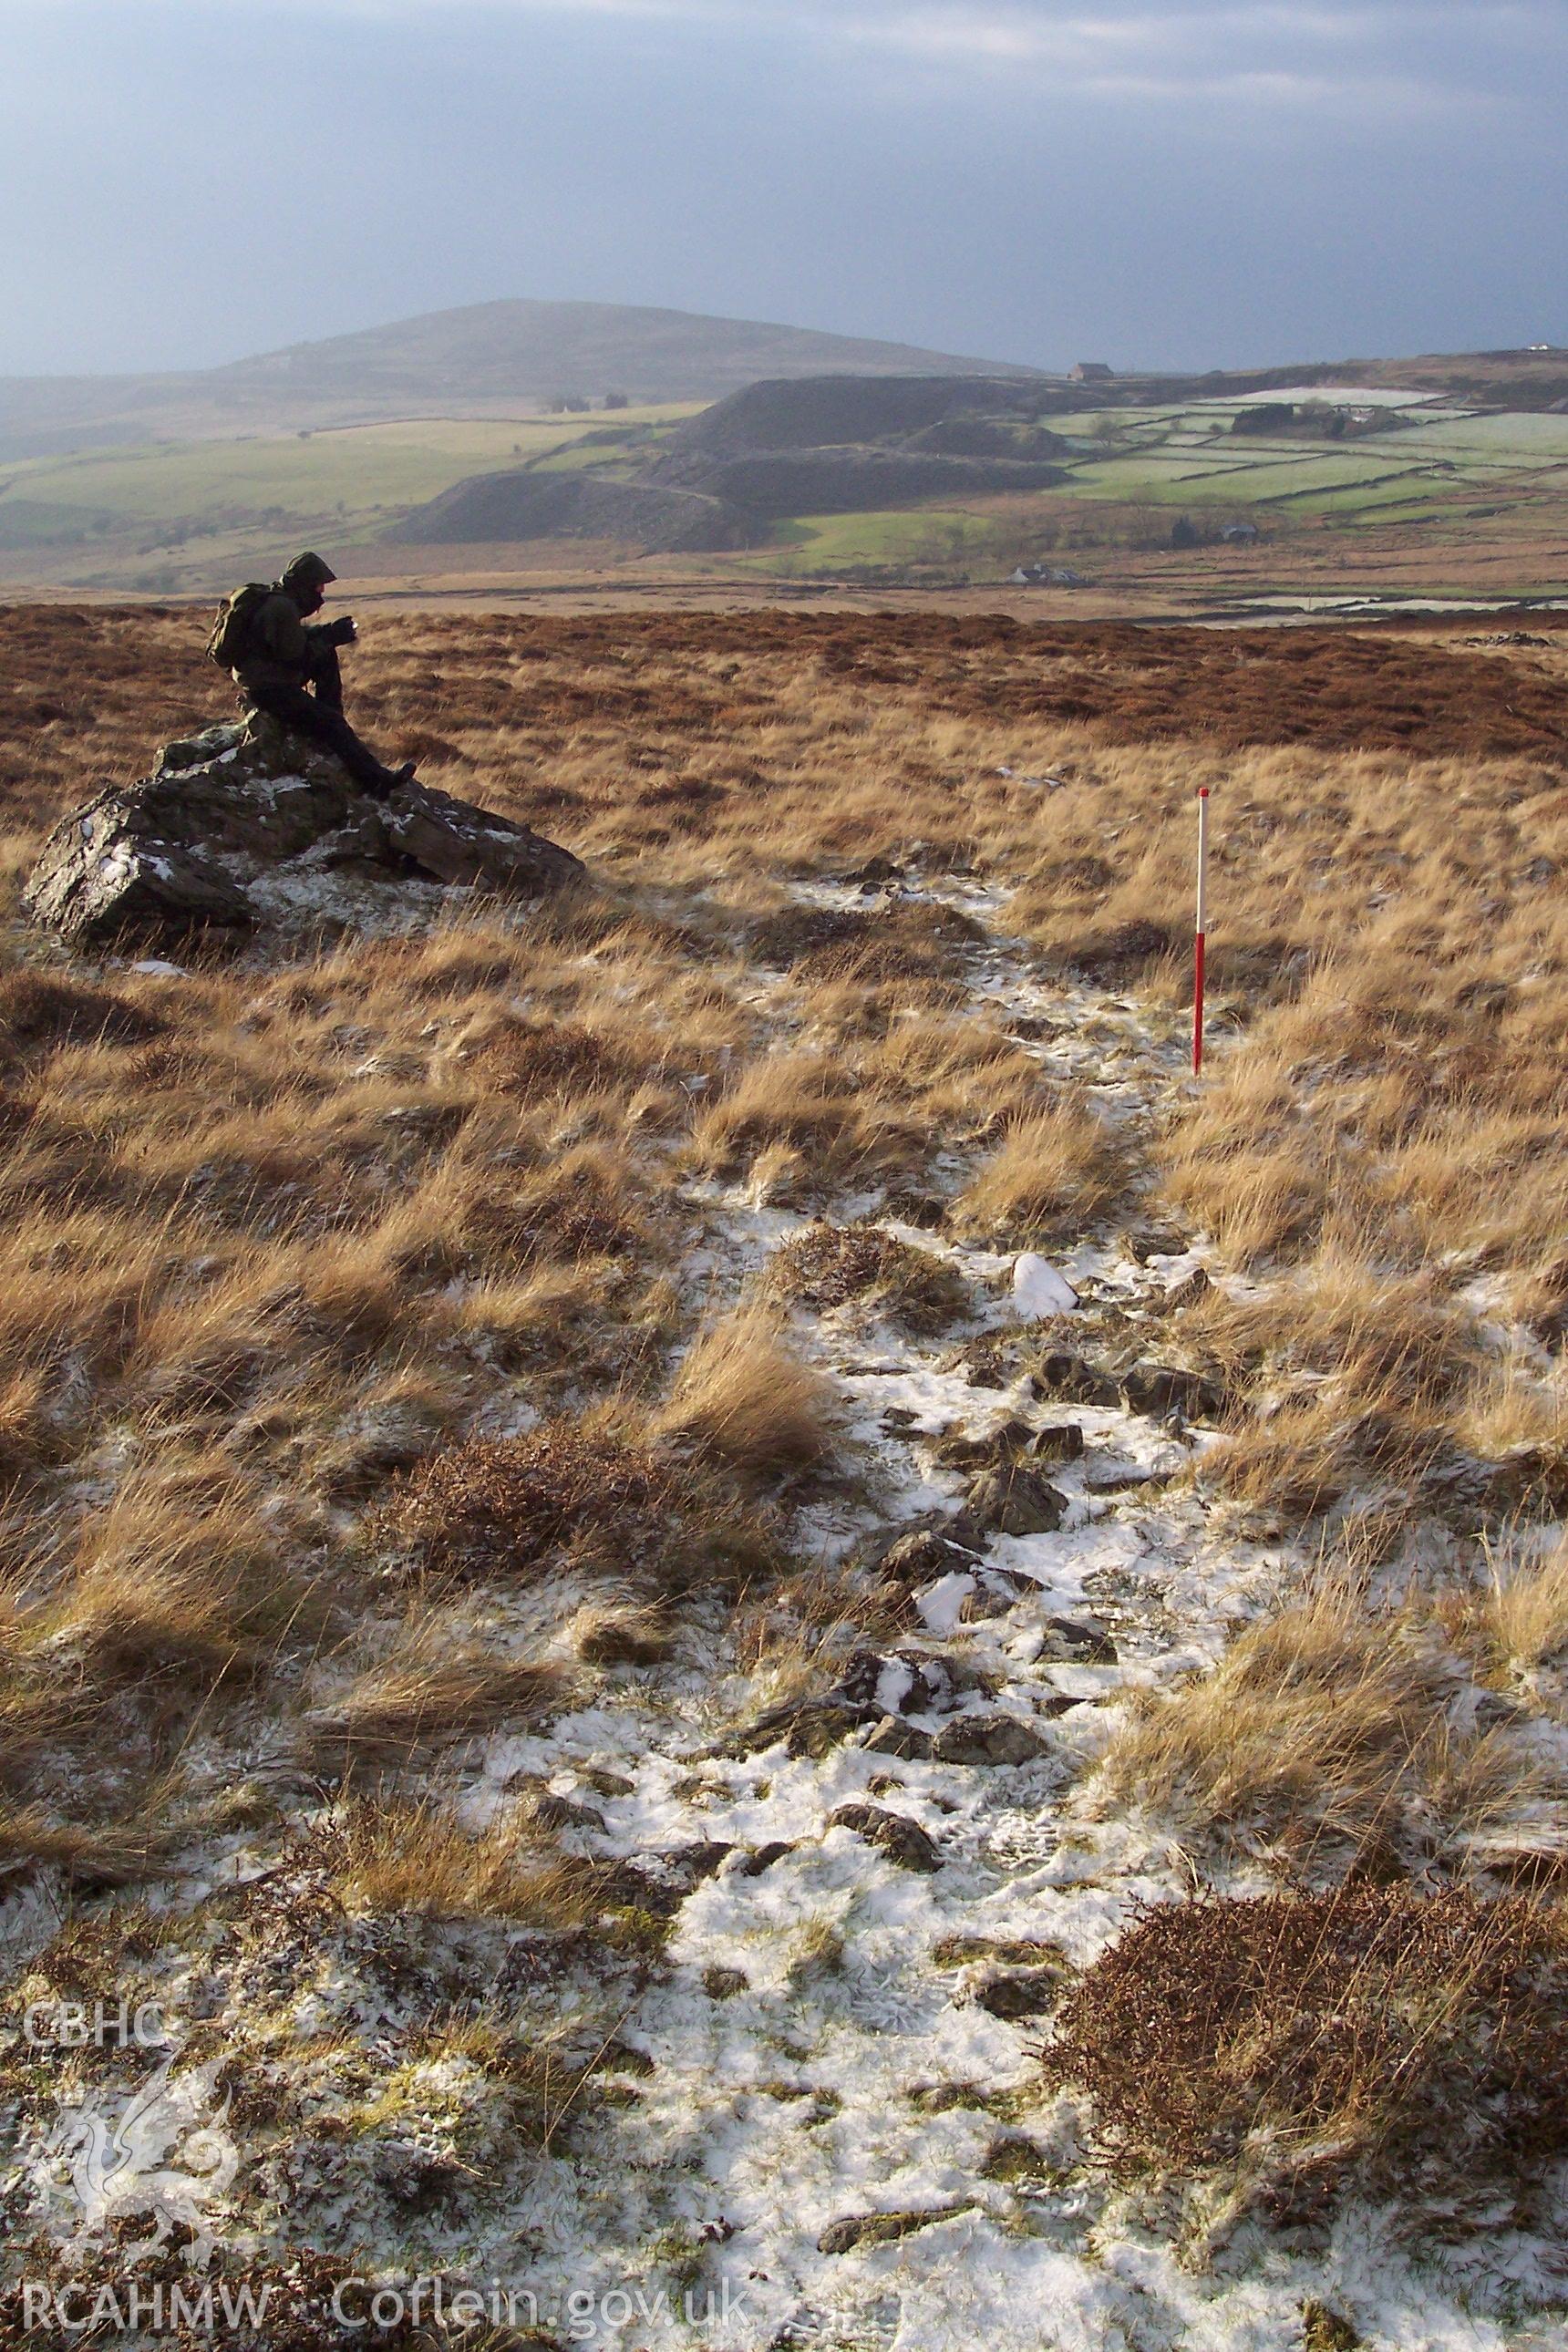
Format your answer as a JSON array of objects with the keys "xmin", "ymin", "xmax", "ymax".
[{"xmin": 24, "ymin": 719, "xmax": 583, "ymax": 945}]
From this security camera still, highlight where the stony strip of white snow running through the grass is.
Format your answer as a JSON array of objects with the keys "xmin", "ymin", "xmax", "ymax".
[{"xmin": 416, "ymin": 884, "xmax": 1559, "ymax": 2352}]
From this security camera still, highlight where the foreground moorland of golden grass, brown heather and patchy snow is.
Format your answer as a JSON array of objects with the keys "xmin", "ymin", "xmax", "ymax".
[{"xmin": 0, "ymin": 607, "xmax": 1568, "ymax": 2352}]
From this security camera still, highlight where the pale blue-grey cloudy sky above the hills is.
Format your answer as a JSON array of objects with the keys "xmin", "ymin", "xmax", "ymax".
[{"xmin": 0, "ymin": 0, "xmax": 1568, "ymax": 374}]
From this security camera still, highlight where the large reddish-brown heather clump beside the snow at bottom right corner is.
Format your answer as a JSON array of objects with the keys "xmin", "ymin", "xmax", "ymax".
[{"xmin": 1044, "ymin": 1886, "xmax": 1568, "ymax": 2221}]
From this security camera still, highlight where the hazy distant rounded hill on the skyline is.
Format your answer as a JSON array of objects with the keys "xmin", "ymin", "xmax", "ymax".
[{"xmin": 0, "ymin": 301, "xmax": 1037, "ymax": 459}]
